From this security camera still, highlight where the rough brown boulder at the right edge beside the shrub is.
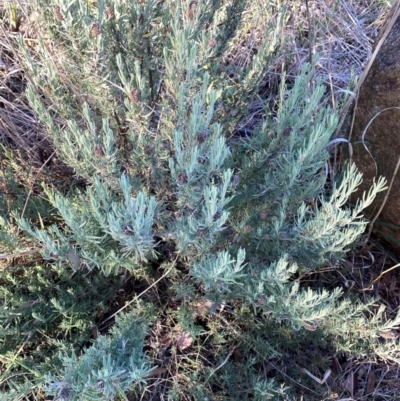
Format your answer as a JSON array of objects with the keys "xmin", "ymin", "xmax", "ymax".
[{"xmin": 351, "ymin": 1, "xmax": 400, "ymax": 254}]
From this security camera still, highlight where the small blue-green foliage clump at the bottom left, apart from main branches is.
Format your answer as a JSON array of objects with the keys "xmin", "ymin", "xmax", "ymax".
[{"xmin": 43, "ymin": 308, "xmax": 152, "ymax": 401}]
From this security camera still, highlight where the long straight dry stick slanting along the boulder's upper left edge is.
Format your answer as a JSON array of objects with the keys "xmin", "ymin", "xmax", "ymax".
[{"xmin": 334, "ymin": 2, "xmax": 400, "ymax": 141}]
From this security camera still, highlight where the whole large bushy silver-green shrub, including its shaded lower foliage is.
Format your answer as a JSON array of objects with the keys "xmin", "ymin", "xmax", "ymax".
[{"xmin": 0, "ymin": 0, "xmax": 400, "ymax": 400}]
